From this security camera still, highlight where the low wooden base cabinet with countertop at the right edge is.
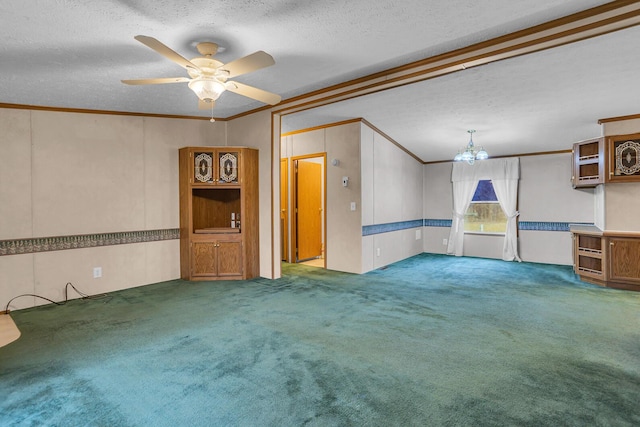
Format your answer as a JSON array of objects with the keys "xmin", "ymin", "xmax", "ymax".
[{"xmin": 571, "ymin": 226, "xmax": 640, "ymax": 291}]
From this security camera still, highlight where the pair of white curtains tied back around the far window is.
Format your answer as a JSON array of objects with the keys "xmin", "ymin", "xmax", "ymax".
[{"xmin": 447, "ymin": 157, "xmax": 521, "ymax": 261}]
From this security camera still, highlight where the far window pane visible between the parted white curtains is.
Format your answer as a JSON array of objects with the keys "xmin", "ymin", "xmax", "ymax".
[{"xmin": 464, "ymin": 180, "xmax": 507, "ymax": 234}]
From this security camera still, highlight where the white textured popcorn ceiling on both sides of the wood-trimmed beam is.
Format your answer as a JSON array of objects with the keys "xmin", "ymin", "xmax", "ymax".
[{"xmin": 0, "ymin": 0, "xmax": 640, "ymax": 161}]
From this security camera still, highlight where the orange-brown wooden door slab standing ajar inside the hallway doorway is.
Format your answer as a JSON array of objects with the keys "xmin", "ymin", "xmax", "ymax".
[{"xmin": 295, "ymin": 159, "xmax": 323, "ymax": 261}]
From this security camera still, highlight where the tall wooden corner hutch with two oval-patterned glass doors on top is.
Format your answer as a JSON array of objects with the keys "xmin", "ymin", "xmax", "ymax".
[{"xmin": 179, "ymin": 147, "xmax": 260, "ymax": 280}]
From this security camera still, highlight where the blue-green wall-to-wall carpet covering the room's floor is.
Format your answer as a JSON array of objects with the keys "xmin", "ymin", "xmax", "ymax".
[{"xmin": 0, "ymin": 254, "xmax": 640, "ymax": 426}]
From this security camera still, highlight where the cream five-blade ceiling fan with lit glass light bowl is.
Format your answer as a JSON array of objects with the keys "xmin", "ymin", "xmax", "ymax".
[{"xmin": 122, "ymin": 36, "xmax": 281, "ymax": 110}]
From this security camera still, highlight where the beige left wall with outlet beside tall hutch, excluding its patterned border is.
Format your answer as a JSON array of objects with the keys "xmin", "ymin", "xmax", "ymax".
[{"xmin": 0, "ymin": 109, "xmax": 226, "ymax": 309}]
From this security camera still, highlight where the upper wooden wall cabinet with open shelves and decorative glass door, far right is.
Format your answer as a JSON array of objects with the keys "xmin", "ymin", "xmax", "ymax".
[{"xmin": 571, "ymin": 134, "xmax": 640, "ymax": 188}]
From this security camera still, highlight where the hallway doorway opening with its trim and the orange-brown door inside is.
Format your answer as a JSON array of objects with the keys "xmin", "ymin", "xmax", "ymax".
[{"xmin": 288, "ymin": 153, "xmax": 326, "ymax": 268}]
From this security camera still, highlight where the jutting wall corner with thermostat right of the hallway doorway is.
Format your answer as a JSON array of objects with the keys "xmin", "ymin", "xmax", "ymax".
[{"xmin": 280, "ymin": 122, "xmax": 423, "ymax": 273}]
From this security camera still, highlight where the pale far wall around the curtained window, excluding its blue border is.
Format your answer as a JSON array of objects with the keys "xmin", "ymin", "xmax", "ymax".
[{"xmin": 424, "ymin": 153, "xmax": 594, "ymax": 265}]
